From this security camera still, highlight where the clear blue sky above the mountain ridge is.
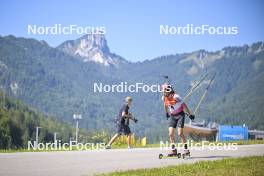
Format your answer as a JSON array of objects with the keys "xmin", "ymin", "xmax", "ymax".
[{"xmin": 0, "ymin": 0, "xmax": 264, "ymax": 61}]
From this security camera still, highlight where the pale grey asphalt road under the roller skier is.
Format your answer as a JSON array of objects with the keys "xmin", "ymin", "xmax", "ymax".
[{"xmin": 0, "ymin": 144, "xmax": 264, "ymax": 176}]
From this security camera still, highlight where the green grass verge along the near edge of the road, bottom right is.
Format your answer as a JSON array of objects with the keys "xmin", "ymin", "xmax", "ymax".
[{"xmin": 97, "ymin": 156, "xmax": 264, "ymax": 176}]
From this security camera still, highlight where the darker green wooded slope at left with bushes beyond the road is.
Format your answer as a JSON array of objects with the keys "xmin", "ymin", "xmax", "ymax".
[{"xmin": 0, "ymin": 92, "xmax": 109, "ymax": 149}]
